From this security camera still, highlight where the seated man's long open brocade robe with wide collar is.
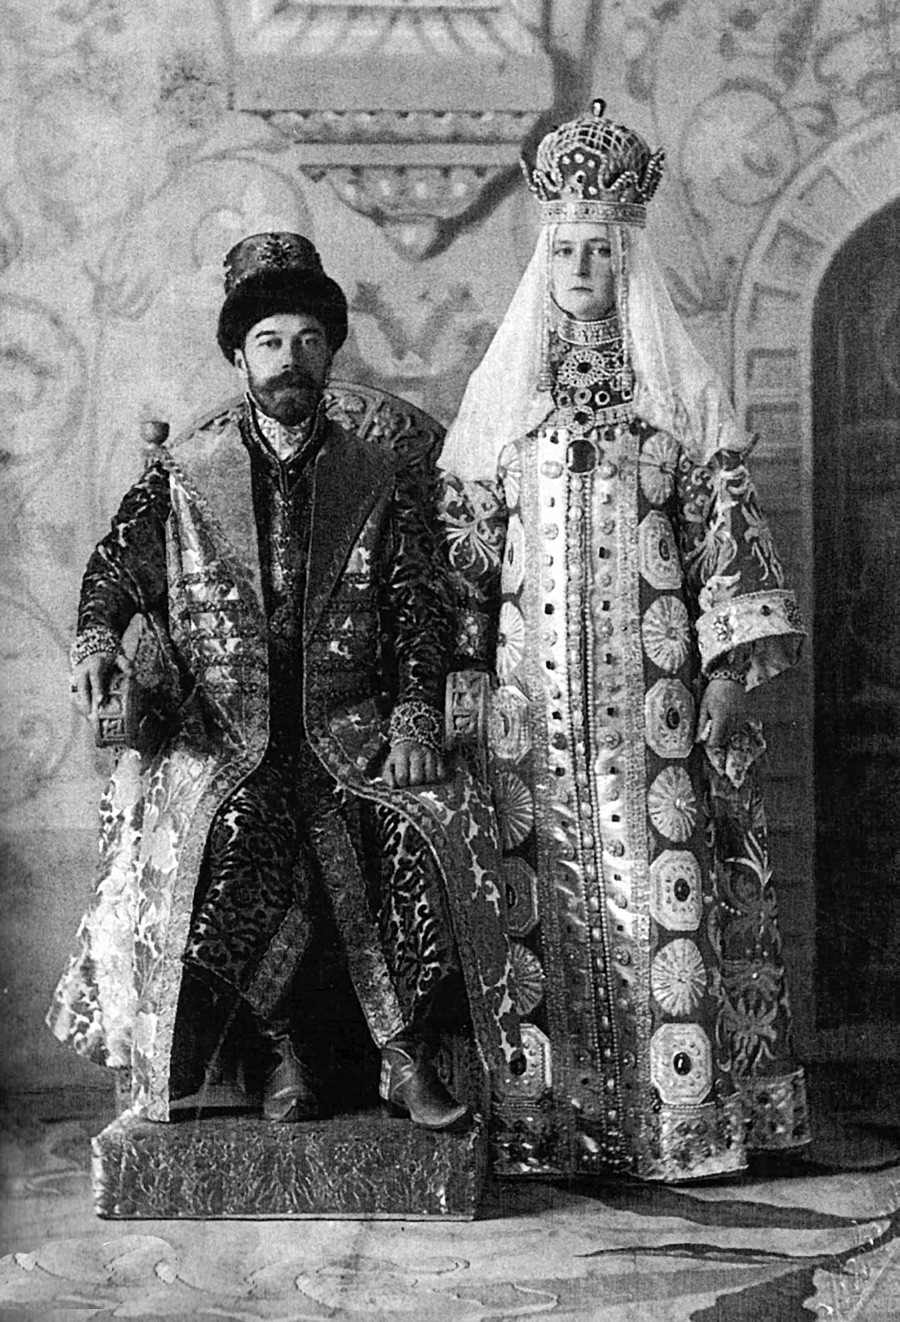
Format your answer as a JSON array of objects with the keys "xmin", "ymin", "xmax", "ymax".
[{"xmin": 49, "ymin": 405, "xmax": 518, "ymax": 1120}]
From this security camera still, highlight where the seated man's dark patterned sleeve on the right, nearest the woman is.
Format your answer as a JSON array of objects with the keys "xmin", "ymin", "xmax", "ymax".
[{"xmin": 379, "ymin": 463, "xmax": 451, "ymax": 743}]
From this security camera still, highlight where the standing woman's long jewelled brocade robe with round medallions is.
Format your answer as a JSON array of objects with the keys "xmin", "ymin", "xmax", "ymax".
[{"xmin": 444, "ymin": 335, "xmax": 809, "ymax": 1181}]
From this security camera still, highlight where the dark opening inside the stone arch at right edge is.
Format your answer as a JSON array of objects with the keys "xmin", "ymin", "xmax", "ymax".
[{"xmin": 813, "ymin": 202, "xmax": 900, "ymax": 1029}]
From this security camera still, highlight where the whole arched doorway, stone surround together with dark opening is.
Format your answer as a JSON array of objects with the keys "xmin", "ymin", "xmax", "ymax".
[{"xmin": 733, "ymin": 112, "xmax": 900, "ymax": 1059}]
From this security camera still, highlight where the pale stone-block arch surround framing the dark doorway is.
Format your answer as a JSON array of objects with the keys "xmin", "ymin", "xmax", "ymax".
[{"xmin": 733, "ymin": 112, "xmax": 900, "ymax": 1056}]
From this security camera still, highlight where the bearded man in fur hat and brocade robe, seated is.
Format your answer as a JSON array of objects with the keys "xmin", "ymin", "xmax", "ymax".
[{"xmin": 49, "ymin": 234, "xmax": 519, "ymax": 1129}]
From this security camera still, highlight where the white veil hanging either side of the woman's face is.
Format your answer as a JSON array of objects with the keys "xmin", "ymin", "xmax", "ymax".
[{"xmin": 440, "ymin": 225, "xmax": 747, "ymax": 481}]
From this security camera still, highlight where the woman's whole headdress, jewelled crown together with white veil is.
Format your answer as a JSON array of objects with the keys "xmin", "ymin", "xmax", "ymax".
[{"xmin": 440, "ymin": 100, "xmax": 745, "ymax": 480}]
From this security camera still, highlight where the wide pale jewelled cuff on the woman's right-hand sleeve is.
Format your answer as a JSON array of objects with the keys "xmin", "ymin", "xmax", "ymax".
[{"xmin": 696, "ymin": 588, "xmax": 806, "ymax": 689}]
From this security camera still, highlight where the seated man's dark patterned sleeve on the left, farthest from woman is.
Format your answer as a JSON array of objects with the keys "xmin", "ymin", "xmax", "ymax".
[{"xmin": 78, "ymin": 463, "xmax": 169, "ymax": 650}]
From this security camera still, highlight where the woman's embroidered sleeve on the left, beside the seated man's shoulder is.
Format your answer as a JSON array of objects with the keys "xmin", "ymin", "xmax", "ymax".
[{"xmin": 439, "ymin": 472, "xmax": 506, "ymax": 669}]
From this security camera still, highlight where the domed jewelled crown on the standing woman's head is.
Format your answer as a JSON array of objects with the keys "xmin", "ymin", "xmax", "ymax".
[{"xmin": 522, "ymin": 100, "xmax": 665, "ymax": 226}]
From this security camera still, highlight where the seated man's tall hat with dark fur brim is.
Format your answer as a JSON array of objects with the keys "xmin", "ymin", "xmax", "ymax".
[{"xmin": 217, "ymin": 233, "xmax": 346, "ymax": 362}]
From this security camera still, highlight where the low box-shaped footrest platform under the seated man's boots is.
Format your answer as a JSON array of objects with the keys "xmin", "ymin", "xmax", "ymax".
[{"xmin": 93, "ymin": 1112, "xmax": 488, "ymax": 1220}]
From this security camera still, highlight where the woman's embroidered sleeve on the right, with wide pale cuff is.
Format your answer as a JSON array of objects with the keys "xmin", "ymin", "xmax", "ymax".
[{"xmin": 677, "ymin": 451, "xmax": 806, "ymax": 689}]
